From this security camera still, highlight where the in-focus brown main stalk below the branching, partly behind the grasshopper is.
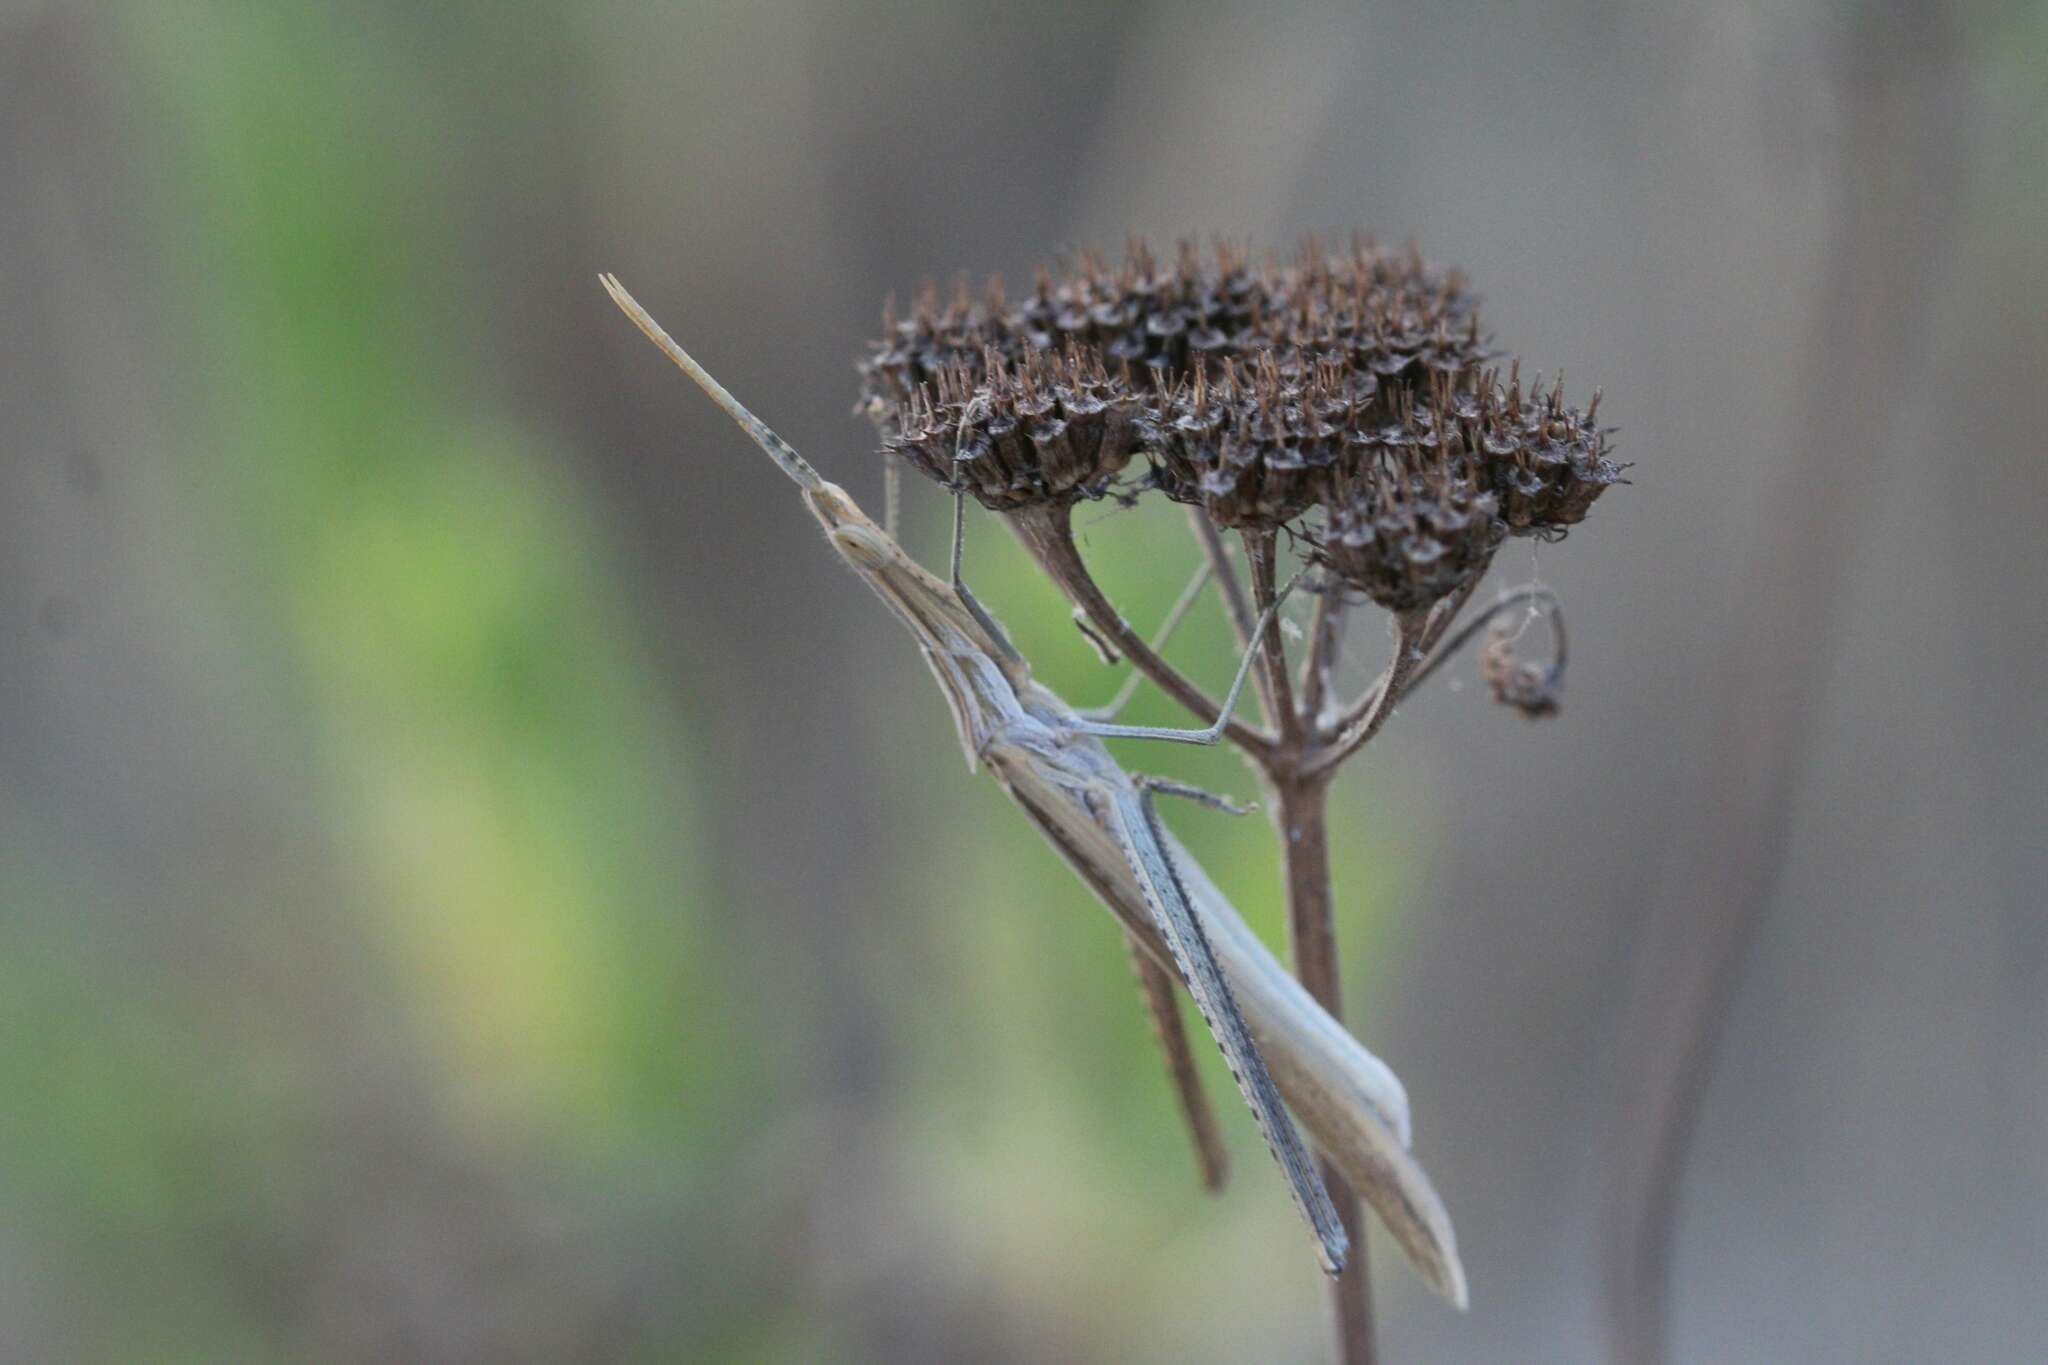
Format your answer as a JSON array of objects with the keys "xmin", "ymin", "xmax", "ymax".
[{"xmin": 1274, "ymin": 778, "xmax": 1378, "ymax": 1365}]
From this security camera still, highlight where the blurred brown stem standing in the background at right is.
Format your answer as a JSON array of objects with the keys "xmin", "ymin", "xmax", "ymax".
[{"xmin": 1606, "ymin": 2, "xmax": 1960, "ymax": 1365}]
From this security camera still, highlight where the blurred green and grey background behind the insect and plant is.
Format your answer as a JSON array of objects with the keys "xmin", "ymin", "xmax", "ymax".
[{"xmin": 0, "ymin": 0, "xmax": 2048, "ymax": 1363}]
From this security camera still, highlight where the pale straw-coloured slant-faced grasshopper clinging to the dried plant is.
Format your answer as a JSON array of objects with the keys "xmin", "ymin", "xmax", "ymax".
[{"xmin": 600, "ymin": 274, "xmax": 1466, "ymax": 1308}]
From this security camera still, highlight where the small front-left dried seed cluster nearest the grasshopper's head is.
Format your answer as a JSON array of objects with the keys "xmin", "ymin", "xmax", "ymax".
[{"xmin": 883, "ymin": 348, "xmax": 1139, "ymax": 512}]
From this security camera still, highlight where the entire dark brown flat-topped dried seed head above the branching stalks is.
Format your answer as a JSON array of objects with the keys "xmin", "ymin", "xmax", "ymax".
[{"xmin": 860, "ymin": 239, "xmax": 1622, "ymax": 610}]
